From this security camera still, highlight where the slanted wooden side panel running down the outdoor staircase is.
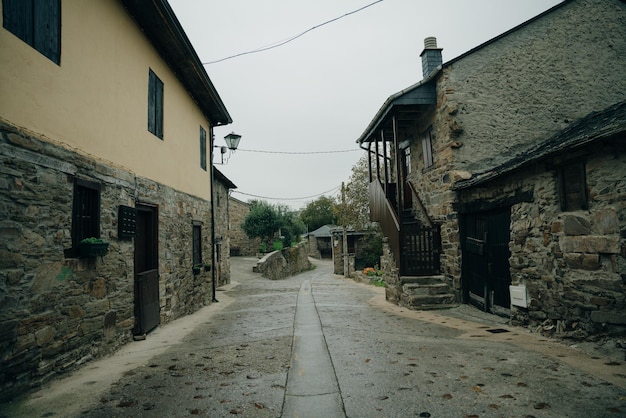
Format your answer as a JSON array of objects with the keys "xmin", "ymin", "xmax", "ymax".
[{"xmin": 369, "ymin": 180, "xmax": 401, "ymax": 267}]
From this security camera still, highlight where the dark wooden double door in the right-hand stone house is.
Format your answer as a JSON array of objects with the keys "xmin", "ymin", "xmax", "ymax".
[{"xmin": 462, "ymin": 208, "xmax": 511, "ymax": 314}]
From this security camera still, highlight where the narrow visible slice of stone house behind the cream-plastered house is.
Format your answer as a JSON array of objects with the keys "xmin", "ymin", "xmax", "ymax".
[{"xmin": 213, "ymin": 167, "xmax": 237, "ymax": 285}]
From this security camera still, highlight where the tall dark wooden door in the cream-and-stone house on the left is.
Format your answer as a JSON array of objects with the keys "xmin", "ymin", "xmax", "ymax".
[{"xmin": 134, "ymin": 205, "xmax": 160, "ymax": 335}]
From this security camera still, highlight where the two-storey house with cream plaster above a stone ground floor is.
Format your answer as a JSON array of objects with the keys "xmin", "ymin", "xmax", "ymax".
[{"xmin": 0, "ymin": 0, "xmax": 231, "ymax": 400}]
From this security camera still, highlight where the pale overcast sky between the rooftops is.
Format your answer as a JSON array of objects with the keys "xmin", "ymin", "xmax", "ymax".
[{"xmin": 169, "ymin": 0, "xmax": 560, "ymax": 209}]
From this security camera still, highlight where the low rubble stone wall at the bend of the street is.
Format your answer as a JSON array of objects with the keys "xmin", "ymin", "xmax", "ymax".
[{"xmin": 254, "ymin": 244, "xmax": 311, "ymax": 280}]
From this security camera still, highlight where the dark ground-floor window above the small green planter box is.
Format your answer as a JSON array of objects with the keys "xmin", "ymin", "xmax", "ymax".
[{"xmin": 65, "ymin": 179, "xmax": 100, "ymax": 257}]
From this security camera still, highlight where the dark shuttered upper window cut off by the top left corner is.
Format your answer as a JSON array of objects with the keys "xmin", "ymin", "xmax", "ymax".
[{"xmin": 2, "ymin": 0, "xmax": 61, "ymax": 64}]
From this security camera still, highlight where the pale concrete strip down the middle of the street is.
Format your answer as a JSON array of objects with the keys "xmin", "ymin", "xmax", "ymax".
[{"xmin": 282, "ymin": 280, "xmax": 346, "ymax": 418}]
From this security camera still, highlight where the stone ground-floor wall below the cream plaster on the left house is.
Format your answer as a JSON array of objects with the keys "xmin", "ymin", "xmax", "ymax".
[{"xmin": 0, "ymin": 124, "xmax": 217, "ymax": 400}]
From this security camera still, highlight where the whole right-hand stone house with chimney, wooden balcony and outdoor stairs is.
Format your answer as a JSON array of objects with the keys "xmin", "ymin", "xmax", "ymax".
[{"xmin": 358, "ymin": 0, "xmax": 626, "ymax": 337}]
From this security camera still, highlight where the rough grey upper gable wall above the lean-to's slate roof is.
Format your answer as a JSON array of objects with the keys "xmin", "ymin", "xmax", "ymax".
[{"xmin": 438, "ymin": 0, "xmax": 626, "ymax": 173}]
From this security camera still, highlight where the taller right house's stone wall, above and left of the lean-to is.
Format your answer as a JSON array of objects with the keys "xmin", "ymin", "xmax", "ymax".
[{"xmin": 398, "ymin": 0, "xmax": 626, "ymax": 300}]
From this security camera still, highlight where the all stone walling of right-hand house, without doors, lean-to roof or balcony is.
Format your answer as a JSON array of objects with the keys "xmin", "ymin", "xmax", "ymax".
[{"xmin": 364, "ymin": 0, "xmax": 626, "ymax": 338}]
